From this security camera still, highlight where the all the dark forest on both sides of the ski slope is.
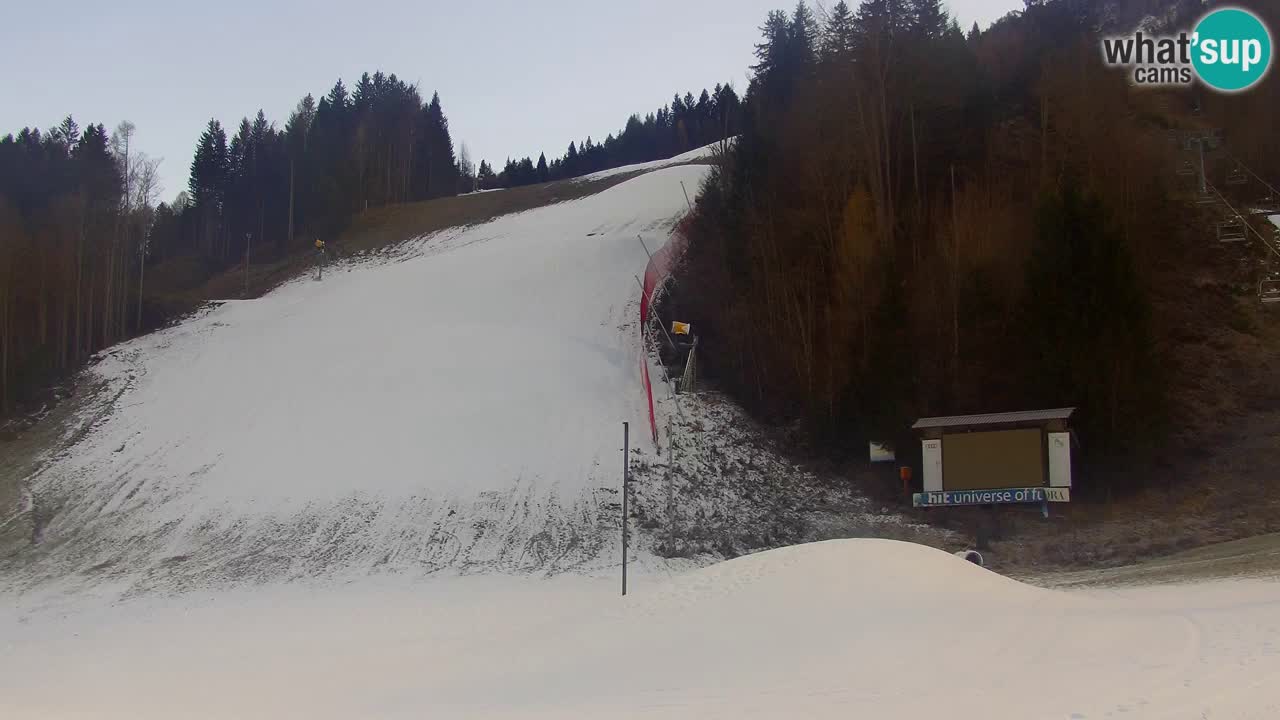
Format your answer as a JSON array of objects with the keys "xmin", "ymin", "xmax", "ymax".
[{"xmin": 10, "ymin": 0, "xmax": 1280, "ymax": 499}]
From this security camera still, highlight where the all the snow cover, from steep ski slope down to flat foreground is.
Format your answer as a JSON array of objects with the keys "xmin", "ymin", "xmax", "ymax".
[{"xmin": 0, "ymin": 142, "xmax": 1280, "ymax": 720}]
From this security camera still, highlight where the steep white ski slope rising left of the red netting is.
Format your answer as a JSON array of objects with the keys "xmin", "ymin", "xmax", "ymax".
[{"xmin": 17, "ymin": 165, "xmax": 707, "ymax": 589}]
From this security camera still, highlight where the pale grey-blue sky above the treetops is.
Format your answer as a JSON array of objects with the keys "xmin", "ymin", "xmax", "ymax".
[{"xmin": 0, "ymin": 0, "xmax": 1023, "ymax": 200}]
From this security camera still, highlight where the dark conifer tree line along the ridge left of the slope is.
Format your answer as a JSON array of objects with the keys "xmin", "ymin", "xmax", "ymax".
[{"xmin": 0, "ymin": 72, "xmax": 740, "ymax": 414}]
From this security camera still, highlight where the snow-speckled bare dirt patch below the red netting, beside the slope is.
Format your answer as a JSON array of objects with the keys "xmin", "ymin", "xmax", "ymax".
[{"xmin": 630, "ymin": 383, "xmax": 964, "ymax": 564}]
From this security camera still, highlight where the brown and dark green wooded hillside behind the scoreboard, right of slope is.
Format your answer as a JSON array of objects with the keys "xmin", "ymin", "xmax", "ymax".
[{"xmin": 672, "ymin": 0, "xmax": 1280, "ymax": 491}]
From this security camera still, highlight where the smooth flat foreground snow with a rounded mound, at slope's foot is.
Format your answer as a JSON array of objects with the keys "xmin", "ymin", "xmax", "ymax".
[{"xmin": 0, "ymin": 539, "xmax": 1280, "ymax": 720}]
